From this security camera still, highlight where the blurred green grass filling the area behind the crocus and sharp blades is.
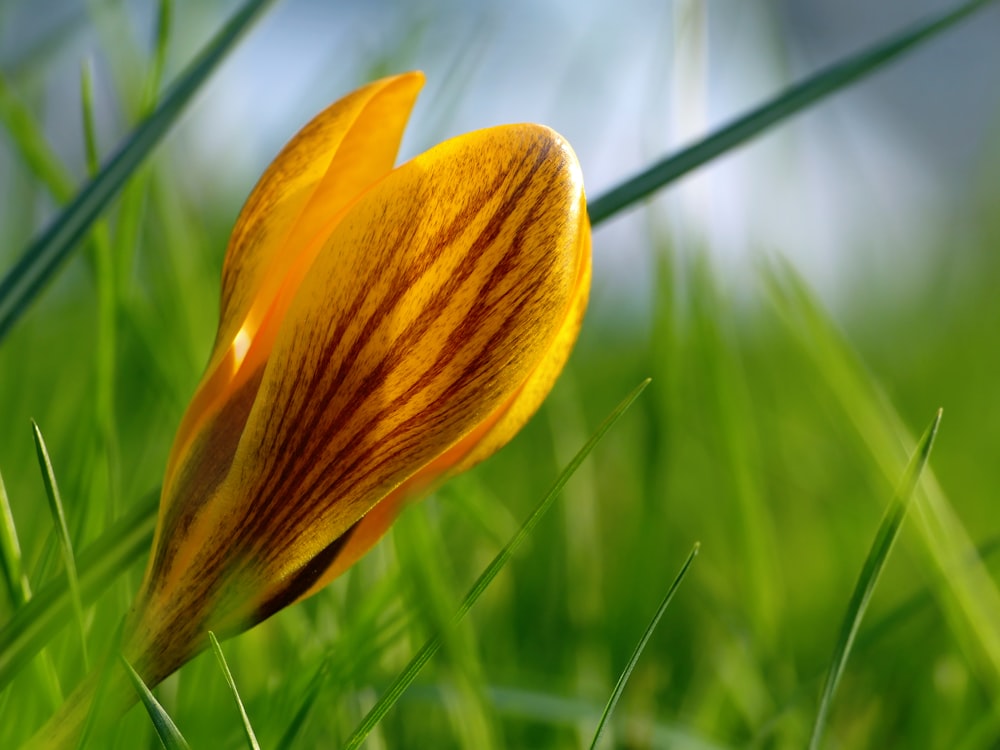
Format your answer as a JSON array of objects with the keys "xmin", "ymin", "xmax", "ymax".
[{"xmin": 0, "ymin": 0, "xmax": 1000, "ymax": 750}]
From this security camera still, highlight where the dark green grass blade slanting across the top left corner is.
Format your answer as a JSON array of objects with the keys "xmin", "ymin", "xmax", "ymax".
[{"xmin": 0, "ymin": 0, "xmax": 273, "ymax": 339}]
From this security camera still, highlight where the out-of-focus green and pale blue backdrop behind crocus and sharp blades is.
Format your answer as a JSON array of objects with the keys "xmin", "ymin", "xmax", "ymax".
[{"xmin": 0, "ymin": 0, "xmax": 1000, "ymax": 748}]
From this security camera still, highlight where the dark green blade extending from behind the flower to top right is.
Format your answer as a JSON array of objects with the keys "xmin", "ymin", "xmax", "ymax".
[{"xmin": 587, "ymin": 0, "xmax": 993, "ymax": 226}]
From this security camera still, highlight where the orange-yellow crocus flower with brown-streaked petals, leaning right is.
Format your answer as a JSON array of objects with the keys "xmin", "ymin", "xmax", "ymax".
[{"xmin": 27, "ymin": 73, "xmax": 590, "ymax": 746}]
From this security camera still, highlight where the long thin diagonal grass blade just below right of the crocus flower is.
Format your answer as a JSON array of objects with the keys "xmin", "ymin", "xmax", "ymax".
[{"xmin": 344, "ymin": 379, "xmax": 649, "ymax": 750}]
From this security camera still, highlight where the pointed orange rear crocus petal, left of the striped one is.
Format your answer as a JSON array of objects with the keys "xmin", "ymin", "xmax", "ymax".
[{"xmin": 164, "ymin": 72, "xmax": 424, "ymax": 500}]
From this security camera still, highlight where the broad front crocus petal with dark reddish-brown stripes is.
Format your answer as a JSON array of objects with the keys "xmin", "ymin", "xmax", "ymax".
[{"xmin": 211, "ymin": 125, "xmax": 585, "ymax": 619}]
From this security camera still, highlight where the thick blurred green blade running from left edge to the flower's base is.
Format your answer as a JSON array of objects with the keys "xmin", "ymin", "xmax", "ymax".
[{"xmin": 0, "ymin": 491, "xmax": 159, "ymax": 690}]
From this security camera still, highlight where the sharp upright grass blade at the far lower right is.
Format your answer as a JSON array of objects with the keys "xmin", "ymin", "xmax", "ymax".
[{"xmin": 809, "ymin": 409, "xmax": 941, "ymax": 750}]
